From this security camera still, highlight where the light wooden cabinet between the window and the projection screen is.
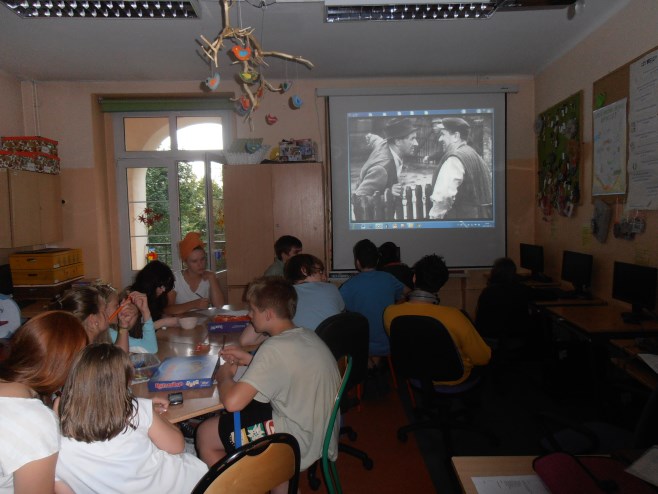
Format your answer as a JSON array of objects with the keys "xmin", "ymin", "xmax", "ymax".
[{"xmin": 223, "ymin": 163, "xmax": 326, "ymax": 304}]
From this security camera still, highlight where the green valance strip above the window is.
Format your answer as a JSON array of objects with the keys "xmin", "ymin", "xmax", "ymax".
[{"xmin": 98, "ymin": 94, "xmax": 235, "ymax": 113}]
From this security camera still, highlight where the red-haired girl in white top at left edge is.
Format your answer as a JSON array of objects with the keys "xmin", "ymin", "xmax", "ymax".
[{"xmin": 0, "ymin": 311, "xmax": 87, "ymax": 494}]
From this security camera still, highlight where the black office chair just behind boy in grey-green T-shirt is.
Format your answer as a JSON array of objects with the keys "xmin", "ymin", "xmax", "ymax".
[{"xmin": 307, "ymin": 312, "xmax": 374, "ymax": 490}]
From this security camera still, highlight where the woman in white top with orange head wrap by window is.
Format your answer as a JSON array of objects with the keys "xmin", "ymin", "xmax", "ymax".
[{"xmin": 165, "ymin": 232, "xmax": 224, "ymax": 314}]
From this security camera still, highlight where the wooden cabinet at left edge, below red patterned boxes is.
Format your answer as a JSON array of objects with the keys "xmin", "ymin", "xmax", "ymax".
[{"xmin": 0, "ymin": 168, "xmax": 62, "ymax": 248}]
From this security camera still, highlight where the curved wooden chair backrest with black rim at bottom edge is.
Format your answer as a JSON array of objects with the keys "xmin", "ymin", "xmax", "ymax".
[{"xmin": 192, "ymin": 433, "xmax": 300, "ymax": 494}]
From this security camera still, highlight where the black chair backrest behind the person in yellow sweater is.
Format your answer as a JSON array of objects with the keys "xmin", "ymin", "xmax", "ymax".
[{"xmin": 391, "ymin": 316, "xmax": 464, "ymax": 381}]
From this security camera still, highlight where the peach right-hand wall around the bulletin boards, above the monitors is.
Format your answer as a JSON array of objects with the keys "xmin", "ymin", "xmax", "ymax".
[{"xmin": 534, "ymin": 0, "xmax": 658, "ymax": 299}]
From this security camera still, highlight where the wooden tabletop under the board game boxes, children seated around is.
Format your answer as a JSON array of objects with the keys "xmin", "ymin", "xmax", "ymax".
[{"xmin": 132, "ymin": 324, "xmax": 240, "ymax": 423}]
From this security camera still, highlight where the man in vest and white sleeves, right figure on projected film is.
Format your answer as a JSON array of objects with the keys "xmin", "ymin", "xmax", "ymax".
[{"xmin": 430, "ymin": 118, "xmax": 493, "ymax": 219}]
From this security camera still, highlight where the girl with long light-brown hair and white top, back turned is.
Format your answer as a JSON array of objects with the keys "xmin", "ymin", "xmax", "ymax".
[{"xmin": 57, "ymin": 343, "xmax": 208, "ymax": 494}]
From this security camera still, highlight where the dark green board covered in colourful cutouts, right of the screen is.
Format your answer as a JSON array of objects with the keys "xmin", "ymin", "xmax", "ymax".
[{"xmin": 535, "ymin": 91, "xmax": 582, "ymax": 217}]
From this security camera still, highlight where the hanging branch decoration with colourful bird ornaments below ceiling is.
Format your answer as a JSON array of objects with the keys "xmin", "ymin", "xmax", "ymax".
[{"xmin": 200, "ymin": 0, "xmax": 313, "ymax": 124}]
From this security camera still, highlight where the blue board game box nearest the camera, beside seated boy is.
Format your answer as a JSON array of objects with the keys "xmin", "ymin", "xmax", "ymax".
[{"xmin": 148, "ymin": 355, "xmax": 217, "ymax": 391}]
